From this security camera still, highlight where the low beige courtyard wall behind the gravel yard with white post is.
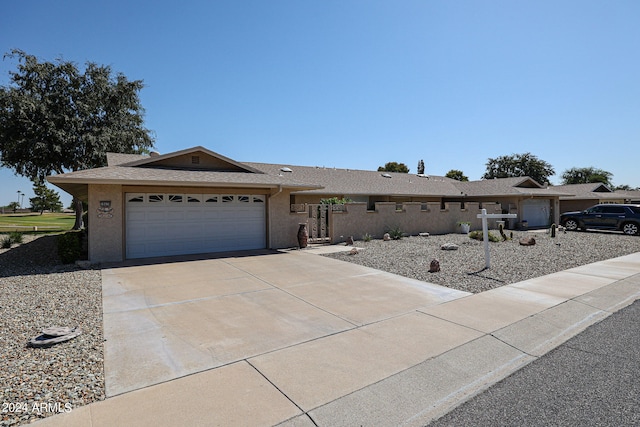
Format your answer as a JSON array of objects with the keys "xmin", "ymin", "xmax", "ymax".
[{"xmin": 330, "ymin": 202, "xmax": 502, "ymax": 243}]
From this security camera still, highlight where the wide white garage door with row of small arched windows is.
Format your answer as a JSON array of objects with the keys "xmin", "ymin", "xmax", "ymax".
[{"xmin": 125, "ymin": 193, "xmax": 266, "ymax": 258}]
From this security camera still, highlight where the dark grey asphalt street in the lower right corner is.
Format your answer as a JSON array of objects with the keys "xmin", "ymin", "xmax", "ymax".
[{"xmin": 429, "ymin": 300, "xmax": 640, "ymax": 427}]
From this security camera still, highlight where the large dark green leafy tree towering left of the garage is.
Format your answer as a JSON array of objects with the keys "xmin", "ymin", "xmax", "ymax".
[{"xmin": 0, "ymin": 49, "xmax": 154, "ymax": 229}]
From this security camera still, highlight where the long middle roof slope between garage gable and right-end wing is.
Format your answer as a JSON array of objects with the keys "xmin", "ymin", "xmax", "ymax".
[{"xmin": 243, "ymin": 162, "xmax": 460, "ymax": 197}]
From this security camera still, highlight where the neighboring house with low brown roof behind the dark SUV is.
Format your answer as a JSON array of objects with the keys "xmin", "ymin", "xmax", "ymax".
[{"xmin": 553, "ymin": 182, "xmax": 626, "ymax": 213}]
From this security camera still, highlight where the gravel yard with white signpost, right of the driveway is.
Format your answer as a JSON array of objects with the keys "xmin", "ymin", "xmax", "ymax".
[{"xmin": 326, "ymin": 230, "xmax": 640, "ymax": 293}]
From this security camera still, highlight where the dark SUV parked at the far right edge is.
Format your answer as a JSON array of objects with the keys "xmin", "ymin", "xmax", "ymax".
[{"xmin": 560, "ymin": 203, "xmax": 640, "ymax": 235}]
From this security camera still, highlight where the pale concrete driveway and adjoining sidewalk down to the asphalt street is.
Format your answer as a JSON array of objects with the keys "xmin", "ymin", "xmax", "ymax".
[{"xmin": 33, "ymin": 251, "xmax": 640, "ymax": 426}]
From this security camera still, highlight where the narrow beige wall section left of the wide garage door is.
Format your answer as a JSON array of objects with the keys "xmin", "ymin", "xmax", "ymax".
[{"xmin": 87, "ymin": 184, "xmax": 124, "ymax": 262}]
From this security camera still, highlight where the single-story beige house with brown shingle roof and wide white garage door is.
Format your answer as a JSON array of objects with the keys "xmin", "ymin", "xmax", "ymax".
[{"xmin": 47, "ymin": 147, "xmax": 564, "ymax": 263}]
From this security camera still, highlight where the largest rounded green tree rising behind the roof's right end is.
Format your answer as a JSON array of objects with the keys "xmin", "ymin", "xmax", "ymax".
[{"xmin": 482, "ymin": 153, "xmax": 555, "ymax": 184}]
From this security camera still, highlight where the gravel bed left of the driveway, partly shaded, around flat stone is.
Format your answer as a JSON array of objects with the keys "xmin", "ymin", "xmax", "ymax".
[{"xmin": 0, "ymin": 235, "xmax": 105, "ymax": 426}]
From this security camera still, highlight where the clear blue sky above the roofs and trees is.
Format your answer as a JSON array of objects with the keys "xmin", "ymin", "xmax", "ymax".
[{"xmin": 0, "ymin": 0, "xmax": 640, "ymax": 205}]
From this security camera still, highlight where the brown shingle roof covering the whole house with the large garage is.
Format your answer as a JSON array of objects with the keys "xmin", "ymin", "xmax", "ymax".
[{"xmin": 49, "ymin": 147, "xmax": 580, "ymax": 198}]
